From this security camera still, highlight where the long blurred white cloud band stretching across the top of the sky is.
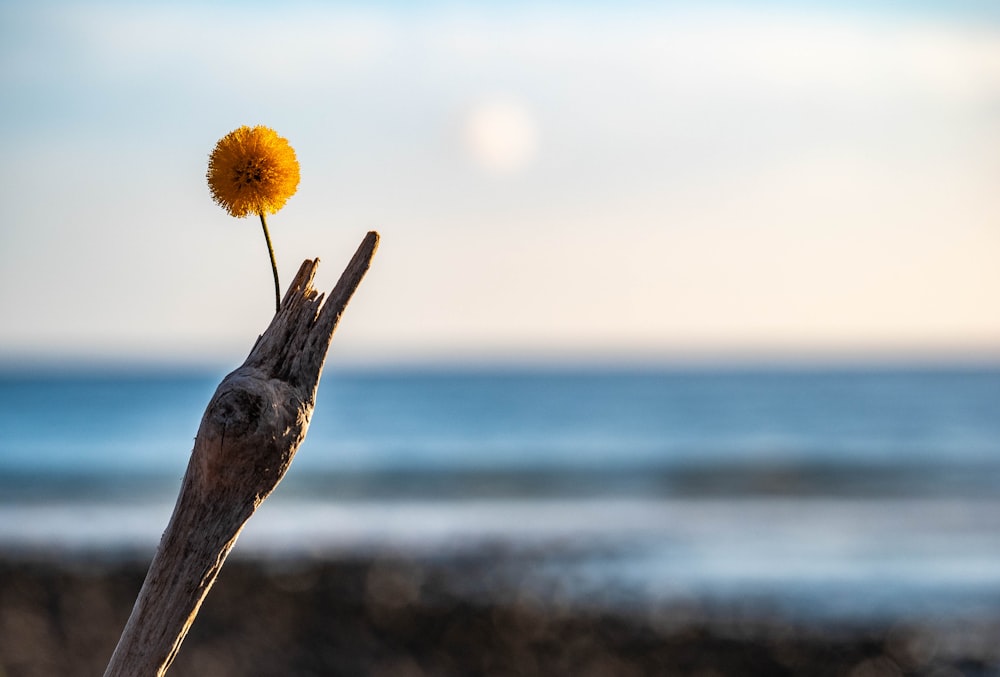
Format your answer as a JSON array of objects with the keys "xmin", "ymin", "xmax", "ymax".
[{"xmin": 20, "ymin": 3, "xmax": 1000, "ymax": 98}]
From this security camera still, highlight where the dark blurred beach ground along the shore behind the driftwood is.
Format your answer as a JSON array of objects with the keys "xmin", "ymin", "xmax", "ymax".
[{"xmin": 0, "ymin": 553, "xmax": 1000, "ymax": 677}]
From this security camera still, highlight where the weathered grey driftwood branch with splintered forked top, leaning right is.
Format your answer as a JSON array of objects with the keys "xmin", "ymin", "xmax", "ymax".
[{"xmin": 104, "ymin": 231, "xmax": 379, "ymax": 677}]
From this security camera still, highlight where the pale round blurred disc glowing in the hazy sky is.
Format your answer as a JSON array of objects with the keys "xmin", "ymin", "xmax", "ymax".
[{"xmin": 463, "ymin": 97, "xmax": 538, "ymax": 174}]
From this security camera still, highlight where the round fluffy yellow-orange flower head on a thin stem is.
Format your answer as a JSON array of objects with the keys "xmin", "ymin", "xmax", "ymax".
[{"xmin": 207, "ymin": 125, "xmax": 299, "ymax": 217}]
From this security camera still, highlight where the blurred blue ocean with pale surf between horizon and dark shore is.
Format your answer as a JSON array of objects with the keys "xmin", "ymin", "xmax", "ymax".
[{"xmin": 0, "ymin": 365, "xmax": 1000, "ymax": 620}]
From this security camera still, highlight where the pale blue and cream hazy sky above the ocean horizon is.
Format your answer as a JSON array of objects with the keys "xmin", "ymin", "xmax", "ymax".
[{"xmin": 0, "ymin": 0, "xmax": 1000, "ymax": 364}]
